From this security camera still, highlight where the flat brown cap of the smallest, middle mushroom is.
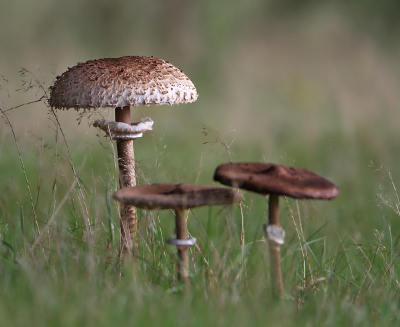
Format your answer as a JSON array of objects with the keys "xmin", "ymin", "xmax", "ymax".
[{"xmin": 113, "ymin": 183, "xmax": 241, "ymax": 209}]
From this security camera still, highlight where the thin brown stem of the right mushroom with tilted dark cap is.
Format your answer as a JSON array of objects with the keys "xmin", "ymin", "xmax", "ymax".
[{"xmin": 266, "ymin": 194, "xmax": 284, "ymax": 298}]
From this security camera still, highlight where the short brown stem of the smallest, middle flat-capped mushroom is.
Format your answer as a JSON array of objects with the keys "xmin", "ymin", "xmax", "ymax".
[{"xmin": 175, "ymin": 208, "xmax": 189, "ymax": 284}]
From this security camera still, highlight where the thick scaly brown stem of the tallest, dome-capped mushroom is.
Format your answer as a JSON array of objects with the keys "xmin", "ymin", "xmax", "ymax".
[{"xmin": 115, "ymin": 106, "xmax": 136, "ymax": 254}]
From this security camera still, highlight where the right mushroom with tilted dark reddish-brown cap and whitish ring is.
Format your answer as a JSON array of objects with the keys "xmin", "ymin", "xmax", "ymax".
[{"xmin": 214, "ymin": 162, "xmax": 339, "ymax": 297}]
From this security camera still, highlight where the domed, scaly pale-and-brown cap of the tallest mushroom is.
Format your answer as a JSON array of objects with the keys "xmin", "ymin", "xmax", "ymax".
[{"xmin": 49, "ymin": 56, "xmax": 198, "ymax": 109}]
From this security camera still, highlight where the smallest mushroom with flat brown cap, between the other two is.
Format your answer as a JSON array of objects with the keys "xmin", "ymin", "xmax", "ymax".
[{"xmin": 113, "ymin": 184, "xmax": 241, "ymax": 283}]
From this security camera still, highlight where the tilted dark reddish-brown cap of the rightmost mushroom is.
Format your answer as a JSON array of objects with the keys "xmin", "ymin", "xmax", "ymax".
[{"xmin": 214, "ymin": 162, "xmax": 339, "ymax": 199}]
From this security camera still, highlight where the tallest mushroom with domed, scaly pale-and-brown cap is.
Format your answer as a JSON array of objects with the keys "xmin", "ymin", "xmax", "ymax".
[{"xmin": 49, "ymin": 56, "xmax": 198, "ymax": 252}]
